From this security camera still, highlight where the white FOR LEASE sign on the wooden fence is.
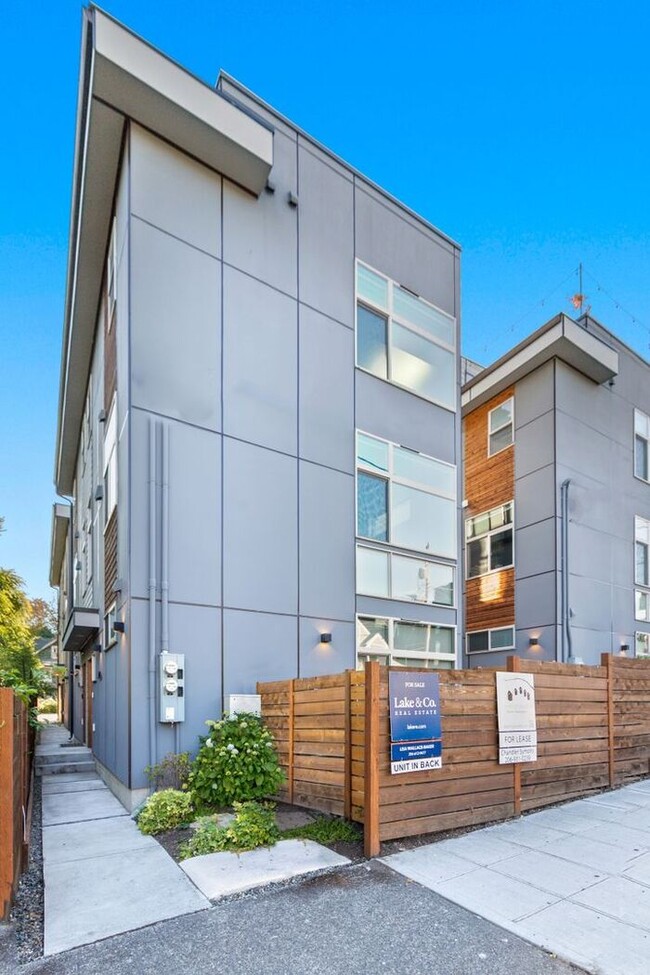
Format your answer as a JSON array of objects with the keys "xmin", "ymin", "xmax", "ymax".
[{"xmin": 496, "ymin": 673, "xmax": 537, "ymax": 765}]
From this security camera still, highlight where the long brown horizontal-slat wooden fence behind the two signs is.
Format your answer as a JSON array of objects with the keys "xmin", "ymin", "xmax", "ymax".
[{"xmin": 258, "ymin": 654, "xmax": 650, "ymax": 855}]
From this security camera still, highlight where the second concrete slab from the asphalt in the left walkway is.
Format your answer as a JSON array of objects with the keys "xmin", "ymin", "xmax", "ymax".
[{"xmin": 43, "ymin": 816, "xmax": 154, "ymax": 869}]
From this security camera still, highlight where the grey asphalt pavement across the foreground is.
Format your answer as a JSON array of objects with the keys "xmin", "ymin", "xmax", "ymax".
[{"xmin": 0, "ymin": 862, "xmax": 578, "ymax": 975}]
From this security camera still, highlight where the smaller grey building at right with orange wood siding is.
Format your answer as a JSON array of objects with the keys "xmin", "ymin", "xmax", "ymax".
[{"xmin": 462, "ymin": 315, "xmax": 650, "ymax": 667}]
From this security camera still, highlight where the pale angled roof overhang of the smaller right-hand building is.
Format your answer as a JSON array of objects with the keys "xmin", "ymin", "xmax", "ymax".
[{"xmin": 462, "ymin": 314, "xmax": 618, "ymax": 414}]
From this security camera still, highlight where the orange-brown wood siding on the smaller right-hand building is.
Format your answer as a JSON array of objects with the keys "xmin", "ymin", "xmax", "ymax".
[{"xmin": 463, "ymin": 386, "xmax": 517, "ymax": 631}]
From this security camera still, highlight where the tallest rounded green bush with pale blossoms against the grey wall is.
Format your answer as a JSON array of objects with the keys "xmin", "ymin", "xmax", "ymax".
[{"xmin": 187, "ymin": 714, "xmax": 284, "ymax": 809}]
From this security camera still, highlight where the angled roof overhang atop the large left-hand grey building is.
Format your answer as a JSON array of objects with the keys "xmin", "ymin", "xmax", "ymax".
[{"xmin": 55, "ymin": 6, "xmax": 273, "ymax": 495}]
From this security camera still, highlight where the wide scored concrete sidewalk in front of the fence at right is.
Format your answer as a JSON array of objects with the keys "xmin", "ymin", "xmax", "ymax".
[{"xmin": 383, "ymin": 781, "xmax": 650, "ymax": 975}]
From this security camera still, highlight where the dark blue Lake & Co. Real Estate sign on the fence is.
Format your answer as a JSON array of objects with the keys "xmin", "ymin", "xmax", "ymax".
[{"xmin": 388, "ymin": 670, "xmax": 442, "ymax": 773}]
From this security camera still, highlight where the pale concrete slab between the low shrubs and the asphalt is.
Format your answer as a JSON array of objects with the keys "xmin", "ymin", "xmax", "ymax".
[{"xmin": 181, "ymin": 840, "xmax": 350, "ymax": 900}]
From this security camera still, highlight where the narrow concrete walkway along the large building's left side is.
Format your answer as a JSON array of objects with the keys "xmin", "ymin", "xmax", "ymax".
[{"xmin": 37, "ymin": 726, "xmax": 210, "ymax": 955}]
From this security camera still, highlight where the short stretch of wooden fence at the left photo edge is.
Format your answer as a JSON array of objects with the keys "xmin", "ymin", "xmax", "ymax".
[{"xmin": 0, "ymin": 687, "xmax": 33, "ymax": 919}]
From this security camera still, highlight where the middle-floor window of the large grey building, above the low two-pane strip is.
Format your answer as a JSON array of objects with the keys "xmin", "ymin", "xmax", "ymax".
[{"xmin": 357, "ymin": 433, "xmax": 456, "ymax": 559}]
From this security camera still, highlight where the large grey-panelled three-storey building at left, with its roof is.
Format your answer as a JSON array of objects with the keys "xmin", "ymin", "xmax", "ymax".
[{"xmin": 51, "ymin": 7, "xmax": 462, "ymax": 805}]
